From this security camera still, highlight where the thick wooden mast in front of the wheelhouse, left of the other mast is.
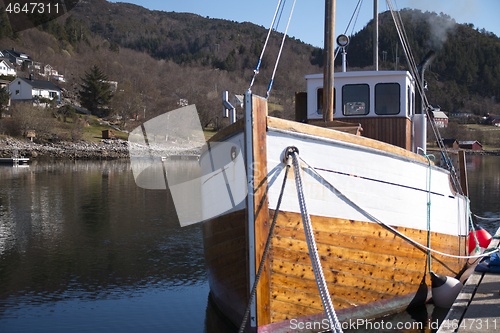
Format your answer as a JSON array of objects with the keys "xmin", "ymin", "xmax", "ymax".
[{"xmin": 323, "ymin": 0, "xmax": 335, "ymax": 122}]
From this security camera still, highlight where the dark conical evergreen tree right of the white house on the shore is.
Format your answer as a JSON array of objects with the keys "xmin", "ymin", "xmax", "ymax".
[{"xmin": 79, "ymin": 65, "xmax": 113, "ymax": 114}]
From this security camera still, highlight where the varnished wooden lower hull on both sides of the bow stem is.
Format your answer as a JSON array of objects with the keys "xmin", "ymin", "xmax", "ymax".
[{"xmin": 203, "ymin": 210, "xmax": 466, "ymax": 332}]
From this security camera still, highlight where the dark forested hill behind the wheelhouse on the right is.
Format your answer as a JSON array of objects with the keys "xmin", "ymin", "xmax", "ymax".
[{"xmin": 348, "ymin": 10, "xmax": 500, "ymax": 115}]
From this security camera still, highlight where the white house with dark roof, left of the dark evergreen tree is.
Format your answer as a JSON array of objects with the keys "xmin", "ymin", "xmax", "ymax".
[{"xmin": 9, "ymin": 75, "xmax": 62, "ymax": 103}]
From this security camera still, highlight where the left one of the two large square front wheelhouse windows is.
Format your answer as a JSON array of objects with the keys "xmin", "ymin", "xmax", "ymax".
[{"xmin": 342, "ymin": 84, "xmax": 370, "ymax": 116}]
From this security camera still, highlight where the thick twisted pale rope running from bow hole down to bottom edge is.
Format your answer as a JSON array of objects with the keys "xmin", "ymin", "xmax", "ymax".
[{"xmin": 291, "ymin": 147, "xmax": 342, "ymax": 333}]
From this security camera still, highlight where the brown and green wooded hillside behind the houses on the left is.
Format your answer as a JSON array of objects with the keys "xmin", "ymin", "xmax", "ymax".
[{"xmin": 0, "ymin": 0, "xmax": 321, "ymax": 130}]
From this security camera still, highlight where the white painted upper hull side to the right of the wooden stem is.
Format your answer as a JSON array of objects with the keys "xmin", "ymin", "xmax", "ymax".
[{"xmin": 267, "ymin": 129, "xmax": 468, "ymax": 236}]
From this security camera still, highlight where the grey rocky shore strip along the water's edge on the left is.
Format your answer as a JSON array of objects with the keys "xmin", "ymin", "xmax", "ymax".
[{"xmin": 0, "ymin": 138, "xmax": 200, "ymax": 160}]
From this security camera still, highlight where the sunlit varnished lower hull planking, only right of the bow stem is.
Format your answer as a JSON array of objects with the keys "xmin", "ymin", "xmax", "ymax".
[{"xmin": 270, "ymin": 212, "xmax": 466, "ymax": 323}]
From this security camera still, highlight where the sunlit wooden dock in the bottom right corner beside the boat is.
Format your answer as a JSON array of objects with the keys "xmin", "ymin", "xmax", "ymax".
[{"xmin": 437, "ymin": 228, "xmax": 500, "ymax": 333}]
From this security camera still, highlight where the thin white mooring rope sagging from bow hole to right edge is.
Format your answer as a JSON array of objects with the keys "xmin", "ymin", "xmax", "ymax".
[{"xmin": 300, "ymin": 158, "xmax": 500, "ymax": 259}]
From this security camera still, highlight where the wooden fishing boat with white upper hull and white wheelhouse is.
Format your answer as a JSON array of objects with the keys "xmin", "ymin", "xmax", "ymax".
[{"xmin": 200, "ymin": 1, "xmax": 469, "ymax": 332}]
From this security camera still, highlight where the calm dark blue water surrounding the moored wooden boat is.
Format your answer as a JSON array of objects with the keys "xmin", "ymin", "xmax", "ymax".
[{"xmin": 0, "ymin": 156, "xmax": 500, "ymax": 333}]
